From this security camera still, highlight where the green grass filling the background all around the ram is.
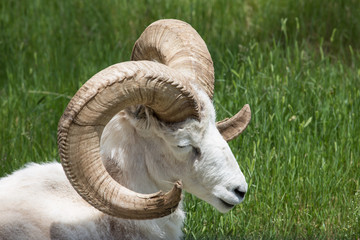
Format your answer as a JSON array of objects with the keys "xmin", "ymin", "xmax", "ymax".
[{"xmin": 0, "ymin": 0, "xmax": 360, "ymax": 239}]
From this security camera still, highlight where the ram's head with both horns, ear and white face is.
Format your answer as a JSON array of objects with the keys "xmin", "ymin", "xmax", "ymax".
[{"xmin": 58, "ymin": 20, "xmax": 251, "ymax": 219}]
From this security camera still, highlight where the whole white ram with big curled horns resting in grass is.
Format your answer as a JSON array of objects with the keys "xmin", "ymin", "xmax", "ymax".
[{"xmin": 0, "ymin": 20, "xmax": 251, "ymax": 239}]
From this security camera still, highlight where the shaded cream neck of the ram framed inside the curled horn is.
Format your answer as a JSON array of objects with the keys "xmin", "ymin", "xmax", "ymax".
[{"xmin": 101, "ymin": 112, "xmax": 163, "ymax": 193}]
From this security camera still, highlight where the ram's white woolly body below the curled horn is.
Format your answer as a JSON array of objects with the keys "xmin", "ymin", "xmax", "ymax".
[{"xmin": 0, "ymin": 163, "xmax": 184, "ymax": 240}]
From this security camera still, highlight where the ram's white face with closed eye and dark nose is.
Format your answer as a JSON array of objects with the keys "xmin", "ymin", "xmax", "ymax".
[{"xmin": 160, "ymin": 96, "xmax": 247, "ymax": 212}]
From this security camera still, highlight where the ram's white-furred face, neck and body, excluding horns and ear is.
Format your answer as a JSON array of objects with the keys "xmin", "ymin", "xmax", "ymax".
[{"xmin": 0, "ymin": 90, "xmax": 247, "ymax": 239}]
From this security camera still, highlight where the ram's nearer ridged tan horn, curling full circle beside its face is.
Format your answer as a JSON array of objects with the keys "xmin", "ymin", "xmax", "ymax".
[{"xmin": 58, "ymin": 61, "xmax": 199, "ymax": 219}]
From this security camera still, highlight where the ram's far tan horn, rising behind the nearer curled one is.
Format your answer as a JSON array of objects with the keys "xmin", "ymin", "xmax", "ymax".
[{"xmin": 131, "ymin": 19, "xmax": 214, "ymax": 99}]
